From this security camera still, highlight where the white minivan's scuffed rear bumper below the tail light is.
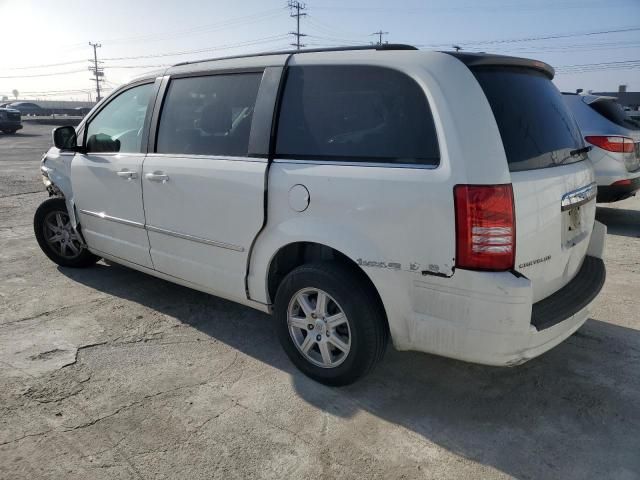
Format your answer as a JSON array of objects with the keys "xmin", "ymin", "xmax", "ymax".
[{"xmin": 392, "ymin": 223, "xmax": 606, "ymax": 366}]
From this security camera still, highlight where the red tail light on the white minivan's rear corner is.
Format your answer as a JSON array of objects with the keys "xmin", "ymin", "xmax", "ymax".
[{"xmin": 453, "ymin": 184, "xmax": 516, "ymax": 271}]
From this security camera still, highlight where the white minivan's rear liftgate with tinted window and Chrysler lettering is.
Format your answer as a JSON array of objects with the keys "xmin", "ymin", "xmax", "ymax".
[{"xmin": 470, "ymin": 61, "xmax": 596, "ymax": 302}]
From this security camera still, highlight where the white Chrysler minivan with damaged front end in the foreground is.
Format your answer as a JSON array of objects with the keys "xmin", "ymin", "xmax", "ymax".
[{"xmin": 34, "ymin": 45, "xmax": 605, "ymax": 385}]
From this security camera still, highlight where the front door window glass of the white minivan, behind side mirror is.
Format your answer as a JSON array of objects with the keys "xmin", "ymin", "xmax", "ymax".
[{"xmin": 86, "ymin": 83, "xmax": 153, "ymax": 153}]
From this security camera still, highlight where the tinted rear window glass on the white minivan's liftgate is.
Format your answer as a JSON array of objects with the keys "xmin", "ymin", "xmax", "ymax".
[{"xmin": 472, "ymin": 67, "xmax": 586, "ymax": 172}]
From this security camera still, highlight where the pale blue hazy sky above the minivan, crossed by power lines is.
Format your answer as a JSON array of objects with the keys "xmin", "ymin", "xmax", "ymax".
[{"xmin": 0, "ymin": 0, "xmax": 640, "ymax": 100}]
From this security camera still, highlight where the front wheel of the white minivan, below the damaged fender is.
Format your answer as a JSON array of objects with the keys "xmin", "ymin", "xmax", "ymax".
[{"xmin": 33, "ymin": 198, "xmax": 100, "ymax": 268}]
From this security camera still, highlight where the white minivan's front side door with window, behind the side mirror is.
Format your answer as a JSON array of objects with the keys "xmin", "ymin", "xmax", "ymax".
[{"xmin": 71, "ymin": 83, "xmax": 154, "ymax": 268}]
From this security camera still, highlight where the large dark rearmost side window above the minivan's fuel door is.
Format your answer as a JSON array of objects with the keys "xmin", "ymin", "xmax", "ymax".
[{"xmin": 276, "ymin": 65, "xmax": 440, "ymax": 165}]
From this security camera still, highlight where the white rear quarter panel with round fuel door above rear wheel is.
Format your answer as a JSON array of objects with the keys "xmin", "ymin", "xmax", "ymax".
[{"xmin": 248, "ymin": 159, "xmax": 455, "ymax": 350}]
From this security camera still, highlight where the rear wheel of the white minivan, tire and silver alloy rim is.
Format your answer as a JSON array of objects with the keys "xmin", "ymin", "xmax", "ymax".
[{"xmin": 274, "ymin": 262, "xmax": 388, "ymax": 386}]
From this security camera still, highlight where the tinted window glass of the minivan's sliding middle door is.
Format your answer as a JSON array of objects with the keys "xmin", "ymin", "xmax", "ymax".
[{"xmin": 156, "ymin": 73, "xmax": 262, "ymax": 156}]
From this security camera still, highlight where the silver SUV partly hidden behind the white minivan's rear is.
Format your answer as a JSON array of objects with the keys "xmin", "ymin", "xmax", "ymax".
[{"xmin": 563, "ymin": 93, "xmax": 640, "ymax": 202}]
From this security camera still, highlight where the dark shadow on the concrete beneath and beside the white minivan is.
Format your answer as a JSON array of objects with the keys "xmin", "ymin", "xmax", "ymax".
[{"xmin": 60, "ymin": 264, "xmax": 640, "ymax": 479}]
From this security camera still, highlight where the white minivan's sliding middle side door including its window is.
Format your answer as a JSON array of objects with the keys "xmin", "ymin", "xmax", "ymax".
[{"xmin": 142, "ymin": 72, "xmax": 270, "ymax": 300}]
